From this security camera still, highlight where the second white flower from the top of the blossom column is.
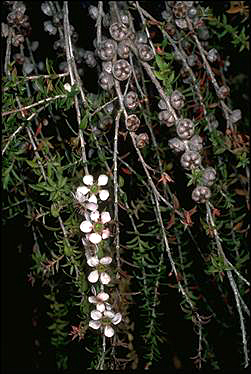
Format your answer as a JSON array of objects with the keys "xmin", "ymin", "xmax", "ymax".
[{"xmin": 80, "ymin": 210, "xmax": 111, "ymax": 244}]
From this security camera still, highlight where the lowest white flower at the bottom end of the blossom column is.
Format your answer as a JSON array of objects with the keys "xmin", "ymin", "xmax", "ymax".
[{"xmin": 89, "ymin": 310, "xmax": 122, "ymax": 338}]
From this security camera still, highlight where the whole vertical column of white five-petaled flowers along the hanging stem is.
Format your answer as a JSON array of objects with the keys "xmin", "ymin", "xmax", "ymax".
[{"xmin": 75, "ymin": 174, "xmax": 122, "ymax": 337}]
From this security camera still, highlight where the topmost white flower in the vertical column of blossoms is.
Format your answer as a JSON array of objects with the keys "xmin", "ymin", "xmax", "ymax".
[{"xmin": 76, "ymin": 174, "xmax": 109, "ymax": 204}]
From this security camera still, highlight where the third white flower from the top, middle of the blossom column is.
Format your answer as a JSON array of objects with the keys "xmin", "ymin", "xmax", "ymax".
[{"xmin": 87, "ymin": 256, "xmax": 112, "ymax": 284}]
